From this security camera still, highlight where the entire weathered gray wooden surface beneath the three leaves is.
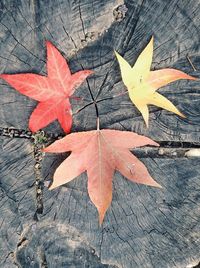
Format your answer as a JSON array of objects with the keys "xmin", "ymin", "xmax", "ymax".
[{"xmin": 0, "ymin": 0, "xmax": 200, "ymax": 268}]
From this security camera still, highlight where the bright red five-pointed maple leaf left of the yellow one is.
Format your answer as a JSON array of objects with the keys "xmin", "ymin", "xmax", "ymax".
[{"xmin": 0, "ymin": 41, "xmax": 93, "ymax": 133}]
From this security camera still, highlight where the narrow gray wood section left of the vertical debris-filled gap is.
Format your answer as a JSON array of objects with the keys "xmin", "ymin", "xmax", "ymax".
[{"xmin": 0, "ymin": 138, "xmax": 35, "ymax": 267}]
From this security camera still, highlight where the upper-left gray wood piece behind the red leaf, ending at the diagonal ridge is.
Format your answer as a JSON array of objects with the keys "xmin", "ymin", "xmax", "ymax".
[{"xmin": 0, "ymin": 0, "xmax": 123, "ymax": 132}]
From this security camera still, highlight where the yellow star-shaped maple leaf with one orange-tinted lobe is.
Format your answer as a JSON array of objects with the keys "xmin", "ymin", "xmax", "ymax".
[{"xmin": 115, "ymin": 37, "xmax": 196, "ymax": 127}]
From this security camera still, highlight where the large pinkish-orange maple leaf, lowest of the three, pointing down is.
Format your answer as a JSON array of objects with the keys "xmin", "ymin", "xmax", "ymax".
[{"xmin": 44, "ymin": 129, "xmax": 161, "ymax": 224}]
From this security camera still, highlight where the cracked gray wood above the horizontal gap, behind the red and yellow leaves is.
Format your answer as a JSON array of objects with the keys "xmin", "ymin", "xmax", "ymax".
[{"xmin": 0, "ymin": 0, "xmax": 200, "ymax": 141}]
